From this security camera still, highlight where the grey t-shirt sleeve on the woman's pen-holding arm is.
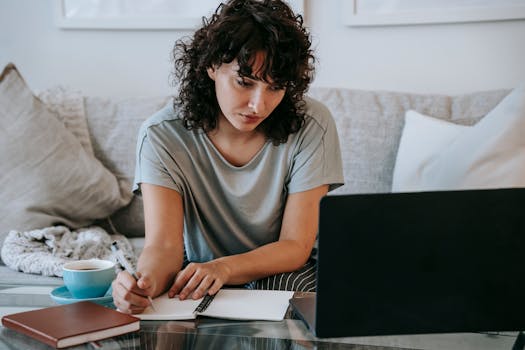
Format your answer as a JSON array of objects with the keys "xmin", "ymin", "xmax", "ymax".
[{"xmin": 133, "ymin": 129, "xmax": 182, "ymax": 194}]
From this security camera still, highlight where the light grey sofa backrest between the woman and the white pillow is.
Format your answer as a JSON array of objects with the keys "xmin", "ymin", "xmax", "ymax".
[{"xmin": 310, "ymin": 87, "xmax": 508, "ymax": 194}]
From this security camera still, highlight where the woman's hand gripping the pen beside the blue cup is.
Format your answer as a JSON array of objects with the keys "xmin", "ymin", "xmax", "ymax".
[{"xmin": 111, "ymin": 271, "xmax": 154, "ymax": 314}]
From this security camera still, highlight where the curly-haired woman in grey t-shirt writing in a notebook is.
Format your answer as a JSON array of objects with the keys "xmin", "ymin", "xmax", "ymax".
[{"xmin": 113, "ymin": 0, "xmax": 343, "ymax": 313}]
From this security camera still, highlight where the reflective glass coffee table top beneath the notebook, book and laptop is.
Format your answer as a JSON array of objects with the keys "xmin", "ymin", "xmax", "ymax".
[{"xmin": 0, "ymin": 282, "xmax": 517, "ymax": 350}]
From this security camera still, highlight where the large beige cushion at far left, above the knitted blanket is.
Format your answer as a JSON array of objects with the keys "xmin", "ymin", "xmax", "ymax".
[{"xmin": 0, "ymin": 65, "xmax": 131, "ymax": 246}]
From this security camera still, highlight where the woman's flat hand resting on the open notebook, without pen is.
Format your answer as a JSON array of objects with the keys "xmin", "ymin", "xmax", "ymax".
[{"xmin": 168, "ymin": 260, "xmax": 230, "ymax": 300}]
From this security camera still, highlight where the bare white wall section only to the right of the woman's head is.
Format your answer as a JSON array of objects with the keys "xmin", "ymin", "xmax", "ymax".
[{"xmin": 309, "ymin": 0, "xmax": 525, "ymax": 93}]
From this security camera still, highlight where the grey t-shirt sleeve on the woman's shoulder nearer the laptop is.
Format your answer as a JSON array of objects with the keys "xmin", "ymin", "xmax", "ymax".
[{"xmin": 288, "ymin": 100, "xmax": 344, "ymax": 193}]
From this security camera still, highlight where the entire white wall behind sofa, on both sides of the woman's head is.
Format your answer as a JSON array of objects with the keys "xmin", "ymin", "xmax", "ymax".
[{"xmin": 0, "ymin": 0, "xmax": 525, "ymax": 96}]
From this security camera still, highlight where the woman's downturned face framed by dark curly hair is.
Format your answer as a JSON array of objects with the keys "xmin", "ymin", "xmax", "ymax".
[{"xmin": 208, "ymin": 53, "xmax": 285, "ymax": 132}]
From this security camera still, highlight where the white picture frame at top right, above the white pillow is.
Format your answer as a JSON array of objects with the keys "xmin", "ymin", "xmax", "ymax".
[{"xmin": 342, "ymin": 0, "xmax": 525, "ymax": 27}]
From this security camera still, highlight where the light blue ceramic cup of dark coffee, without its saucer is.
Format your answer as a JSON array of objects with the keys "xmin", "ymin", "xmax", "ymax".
[{"xmin": 62, "ymin": 259, "xmax": 116, "ymax": 299}]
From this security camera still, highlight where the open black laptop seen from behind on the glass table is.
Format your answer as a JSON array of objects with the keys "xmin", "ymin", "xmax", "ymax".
[{"xmin": 290, "ymin": 189, "xmax": 525, "ymax": 338}]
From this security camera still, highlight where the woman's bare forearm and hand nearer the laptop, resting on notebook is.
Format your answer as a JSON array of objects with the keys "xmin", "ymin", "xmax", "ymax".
[{"xmin": 169, "ymin": 185, "xmax": 328, "ymax": 299}]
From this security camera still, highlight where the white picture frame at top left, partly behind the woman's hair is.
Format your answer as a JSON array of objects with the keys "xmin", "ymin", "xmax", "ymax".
[{"xmin": 54, "ymin": 0, "xmax": 304, "ymax": 30}]
